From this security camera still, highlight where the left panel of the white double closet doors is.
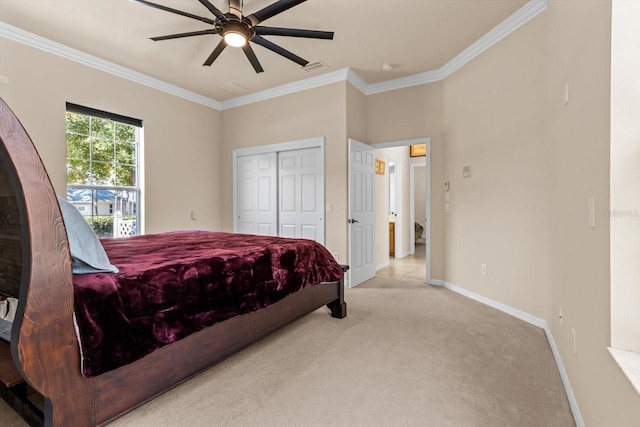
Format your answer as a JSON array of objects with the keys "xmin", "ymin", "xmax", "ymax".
[{"xmin": 236, "ymin": 153, "xmax": 278, "ymax": 236}]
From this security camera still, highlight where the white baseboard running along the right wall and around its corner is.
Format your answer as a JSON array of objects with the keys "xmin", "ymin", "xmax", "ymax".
[{"xmin": 430, "ymin": 279, "xmax": 584, "ymax": 427}]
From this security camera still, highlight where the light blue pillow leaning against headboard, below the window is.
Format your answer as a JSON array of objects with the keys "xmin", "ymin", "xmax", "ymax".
[{"xmin": 58, "ymin": 196, "xmax": 118, "ymax": 274}]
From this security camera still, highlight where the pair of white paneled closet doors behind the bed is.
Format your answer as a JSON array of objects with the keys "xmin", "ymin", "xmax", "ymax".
[{"xmin": 236, "ymin": 147, "xmax": 325, "ymax": 244}]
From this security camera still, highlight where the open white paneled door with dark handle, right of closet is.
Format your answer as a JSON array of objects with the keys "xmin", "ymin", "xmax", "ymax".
[{"xmin": 348, "ymin": 139, "xmax": 376, "ymax": 287}]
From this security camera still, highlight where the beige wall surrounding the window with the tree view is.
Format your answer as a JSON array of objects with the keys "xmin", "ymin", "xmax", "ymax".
[{"xmin": 0, "ymin": 38, "xmax": 222, "ymax": 233}]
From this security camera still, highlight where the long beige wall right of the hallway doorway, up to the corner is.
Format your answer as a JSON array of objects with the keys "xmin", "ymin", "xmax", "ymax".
[{"xmin": 436, "ymin": 0, "xmax": 551, "ymax": 317}]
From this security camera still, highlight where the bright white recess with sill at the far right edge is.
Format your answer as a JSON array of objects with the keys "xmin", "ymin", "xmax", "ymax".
[{"xmin": 607, "ymin": 1, "xmax": 640, "ymax": 393}]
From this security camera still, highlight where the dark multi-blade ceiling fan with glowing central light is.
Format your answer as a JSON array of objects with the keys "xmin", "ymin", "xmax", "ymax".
[{"xmin": 133, "ymin": 0, "xmax": 333, "ymax": 73}]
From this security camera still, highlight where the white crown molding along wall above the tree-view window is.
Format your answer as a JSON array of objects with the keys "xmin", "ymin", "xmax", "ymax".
[{"xmin": 0, "ymin": 21, "xmax": 221, "ymax": 110}]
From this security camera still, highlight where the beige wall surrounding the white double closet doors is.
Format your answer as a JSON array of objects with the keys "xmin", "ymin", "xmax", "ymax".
[{"xmin": 221, "ymin": 82, "xmax": 350, "ymax": 263}]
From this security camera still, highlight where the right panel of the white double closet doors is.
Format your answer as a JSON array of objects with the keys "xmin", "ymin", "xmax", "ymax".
[{"xmin": 278, "ymin": 147, "xmax": 324, "ymax": 244}]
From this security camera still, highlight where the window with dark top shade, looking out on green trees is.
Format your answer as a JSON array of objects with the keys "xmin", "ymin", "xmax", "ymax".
[{"xmin": 67, "ymin": 103, "xmax": 142, "ymax": 237}]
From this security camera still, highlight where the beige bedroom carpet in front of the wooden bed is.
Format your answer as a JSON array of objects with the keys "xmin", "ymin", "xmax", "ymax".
[{"xmin": 0, "ymin": 283, "xmax": 575, "ymax": 427}]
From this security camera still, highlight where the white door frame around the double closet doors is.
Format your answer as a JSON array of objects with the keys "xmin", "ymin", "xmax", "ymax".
[{"xmin": 231, "ymin": 136, "xmax": 327, "ymax": 242}]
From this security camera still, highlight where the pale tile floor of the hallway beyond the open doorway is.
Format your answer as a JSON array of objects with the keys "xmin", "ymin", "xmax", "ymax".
[{"xmin": 358, "ymin": 239, "xmax": 426, "ymax": 288}]
